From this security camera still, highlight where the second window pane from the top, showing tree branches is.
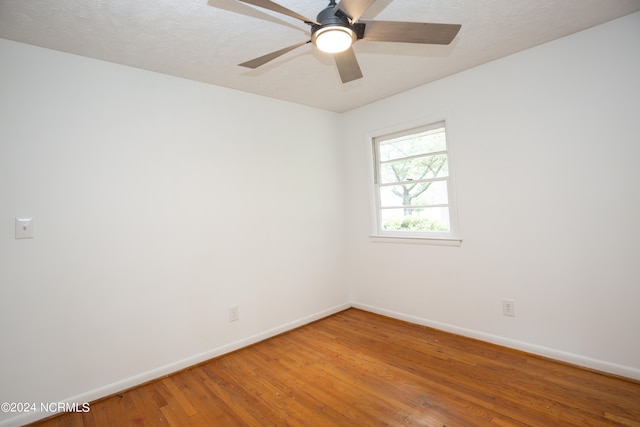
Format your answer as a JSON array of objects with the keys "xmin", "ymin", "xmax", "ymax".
[{"xmin": 380, "ymin": 154, "xmax": 449, "ymax": 184}]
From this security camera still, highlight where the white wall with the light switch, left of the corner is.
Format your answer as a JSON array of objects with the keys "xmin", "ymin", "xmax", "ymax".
[{"xmin": 0, "ymin": 40, "xmax": 348, "ymax": 425}]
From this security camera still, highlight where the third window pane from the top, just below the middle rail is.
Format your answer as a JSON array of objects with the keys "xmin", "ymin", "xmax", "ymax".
[{"xmin": 380, "ymin": 181, "xmax": 448, "ymax": 207}]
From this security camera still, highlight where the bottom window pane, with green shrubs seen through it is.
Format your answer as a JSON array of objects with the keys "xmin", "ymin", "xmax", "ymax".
[{"xmin": 380, "ymin": 208, "xmax": 451, "ymax": 232}]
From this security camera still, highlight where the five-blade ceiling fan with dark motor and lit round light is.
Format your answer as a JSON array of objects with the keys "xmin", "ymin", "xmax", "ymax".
[{"xmin": 232, "ymin": 0, "xmax": 461, "ymax": 83}]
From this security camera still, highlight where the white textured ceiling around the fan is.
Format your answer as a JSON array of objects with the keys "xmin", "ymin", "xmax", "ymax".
[{"xmin": 0, "ymin": 0, "xmax": 640, "ymax": 112}]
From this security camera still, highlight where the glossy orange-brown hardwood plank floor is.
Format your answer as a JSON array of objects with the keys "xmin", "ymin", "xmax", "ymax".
[{"xmin": 28, "ymin": 309, "xmax": 640, "ymax": 427}]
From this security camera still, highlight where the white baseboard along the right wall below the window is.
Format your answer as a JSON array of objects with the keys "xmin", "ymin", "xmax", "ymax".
[{"xmin": 352, "ymin": 303, "xmax": 640, "ymax": 380}]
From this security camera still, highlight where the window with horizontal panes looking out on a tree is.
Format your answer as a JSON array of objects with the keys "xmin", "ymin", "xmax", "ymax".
[{"xmin": 373, "ymin": 122, "xmax": 458, "ymax": 239}]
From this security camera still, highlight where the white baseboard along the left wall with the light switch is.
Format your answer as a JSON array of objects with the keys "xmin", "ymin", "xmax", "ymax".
[{"xmin": 0, "ymin": 303, "xmax": 351, "ymax": 427}]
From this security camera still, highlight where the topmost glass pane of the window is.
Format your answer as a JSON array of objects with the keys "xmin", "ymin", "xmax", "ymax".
[{"xmin": 380, "ymin": 128, "xmax": 447, "ymax": 162}]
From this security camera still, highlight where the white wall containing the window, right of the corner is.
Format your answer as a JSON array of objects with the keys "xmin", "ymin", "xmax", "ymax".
[{"xmin": 341, "ymin": 13, "xmax": 640, "ymax": 379}]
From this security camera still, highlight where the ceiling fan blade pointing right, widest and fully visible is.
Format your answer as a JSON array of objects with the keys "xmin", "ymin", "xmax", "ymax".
[{"xmin": 361, "ymin": 21, "xmax": 462, "ymax": 44}]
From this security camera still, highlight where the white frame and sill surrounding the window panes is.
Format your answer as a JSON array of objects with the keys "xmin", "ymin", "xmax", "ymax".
[{"xmin": 367, "ymin": 118, "xmax": 462, "ymax": 246}]
